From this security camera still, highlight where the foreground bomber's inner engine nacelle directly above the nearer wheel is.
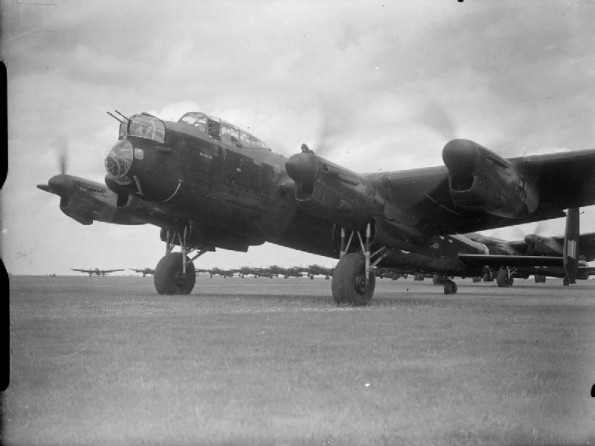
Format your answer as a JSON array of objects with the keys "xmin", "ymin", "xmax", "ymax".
[{"xmin": 285, "ymin": 153, "xmax": 373, "ymax": 228}]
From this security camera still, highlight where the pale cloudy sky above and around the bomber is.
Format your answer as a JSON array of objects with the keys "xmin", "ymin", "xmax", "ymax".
[{"xmin": 1, "ymin": 0, "xmax": 595, "ymax": 274}]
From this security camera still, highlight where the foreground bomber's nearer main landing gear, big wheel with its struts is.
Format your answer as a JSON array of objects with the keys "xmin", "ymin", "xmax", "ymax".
[{"xmin": 331, "ymin": 224, "xmax": 387, "ymax": 306}]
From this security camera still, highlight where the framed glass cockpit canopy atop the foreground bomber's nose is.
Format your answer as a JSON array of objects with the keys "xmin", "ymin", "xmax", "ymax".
[{"xmin": 178, "ymin": 112, "xmax": 271, "ymax": 150}]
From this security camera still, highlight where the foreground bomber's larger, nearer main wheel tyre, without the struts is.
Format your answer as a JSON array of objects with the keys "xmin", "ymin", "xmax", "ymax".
[{"xmin": 331, "ymin": 253, "xmax": 376, "ymax": 306}]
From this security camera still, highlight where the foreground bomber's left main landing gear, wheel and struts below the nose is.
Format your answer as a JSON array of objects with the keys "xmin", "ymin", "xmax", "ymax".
[{"xmin": 153, "ymin": 225, "xmax": 207, "ymax": 295}]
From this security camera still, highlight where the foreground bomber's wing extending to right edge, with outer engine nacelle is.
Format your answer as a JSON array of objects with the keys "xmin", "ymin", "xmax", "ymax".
[{"xmin": 365, "ymin": 147, "xmax": 595, "ymax": 236}]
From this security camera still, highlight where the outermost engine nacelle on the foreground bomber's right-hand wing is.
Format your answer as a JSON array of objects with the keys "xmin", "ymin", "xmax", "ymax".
[{"xmin": 442, "ymin": 139, "xmax": 539, "ymax": 218}]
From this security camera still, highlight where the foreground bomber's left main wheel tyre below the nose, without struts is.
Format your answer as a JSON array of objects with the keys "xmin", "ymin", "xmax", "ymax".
[{"xmin": 153, "ymin": 252, "xmax": 196, "ymax": 295}]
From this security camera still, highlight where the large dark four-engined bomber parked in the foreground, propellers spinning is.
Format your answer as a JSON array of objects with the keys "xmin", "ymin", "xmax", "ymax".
[{"xmin": 38, "ymin": 107, "xmax": 595, "ymax": 305}]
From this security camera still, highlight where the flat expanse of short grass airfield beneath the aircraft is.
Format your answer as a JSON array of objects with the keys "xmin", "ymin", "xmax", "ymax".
[{"xmin": 2, "ymin": 275, "xmax": 595, "ymax": 445}]
